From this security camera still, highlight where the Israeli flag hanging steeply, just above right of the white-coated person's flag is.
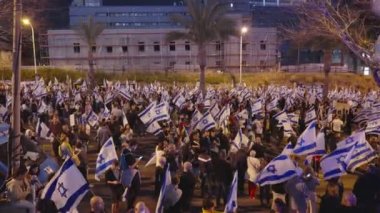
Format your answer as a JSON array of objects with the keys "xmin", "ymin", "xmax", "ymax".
[{"xmin": 293, "ymin": 121, "xmax": 317, "ymax": 155}]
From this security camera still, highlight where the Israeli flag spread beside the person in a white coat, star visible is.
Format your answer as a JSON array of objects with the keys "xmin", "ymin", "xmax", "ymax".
[{"xmin": 256, "ymin": 155, "xmax": 297, "ymax": 186}]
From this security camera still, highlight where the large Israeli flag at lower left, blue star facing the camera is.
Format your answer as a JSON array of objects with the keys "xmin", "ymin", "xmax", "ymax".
[{"xmin": 41, "ymin": 158, "xmax": 90, "ymax": 212}]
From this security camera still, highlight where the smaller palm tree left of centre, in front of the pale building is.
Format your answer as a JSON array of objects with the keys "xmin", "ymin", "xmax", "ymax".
[{"xmin": 75, "ymin": 16, "xmax": 105, "ymax": 89}]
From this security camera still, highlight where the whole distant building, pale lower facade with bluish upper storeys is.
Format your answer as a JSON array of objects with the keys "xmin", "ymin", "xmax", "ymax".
[{"xmin": 40, "ymin": 0, "xmax": 303, "ymax": 71}]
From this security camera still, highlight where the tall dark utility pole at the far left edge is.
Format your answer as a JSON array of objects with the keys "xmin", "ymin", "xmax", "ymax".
[{"xmin": 9, "ymin": 0, "xmax": 22, "ymax": 174}]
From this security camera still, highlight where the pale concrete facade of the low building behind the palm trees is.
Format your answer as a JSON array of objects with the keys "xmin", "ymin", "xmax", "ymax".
[{"xmin": 47, "ymin": 24, "xmax": 277, "ymax": 71}]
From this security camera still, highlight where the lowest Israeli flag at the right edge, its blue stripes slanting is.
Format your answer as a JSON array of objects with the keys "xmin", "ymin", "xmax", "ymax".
[{"xmin": 343, "ymin": 140, "xmax": 378, "ymax": 172}]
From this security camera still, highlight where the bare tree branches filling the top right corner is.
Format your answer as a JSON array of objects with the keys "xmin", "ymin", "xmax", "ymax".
[{"xmin": 297, "ymin": 0, "xmax": 380, "ymax": 81}]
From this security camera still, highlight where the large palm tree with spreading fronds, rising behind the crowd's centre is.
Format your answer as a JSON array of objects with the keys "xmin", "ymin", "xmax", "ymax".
[{"xmin": 166, "ymin": 0, "xmax": 236, "ymax": 95}]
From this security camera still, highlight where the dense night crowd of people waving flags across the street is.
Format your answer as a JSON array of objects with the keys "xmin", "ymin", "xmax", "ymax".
[{"xmin": 0, "ymin": 77, "xmax": 380, "ymax": 213}]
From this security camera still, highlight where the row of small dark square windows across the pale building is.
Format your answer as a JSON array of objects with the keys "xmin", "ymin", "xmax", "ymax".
[{"xmin": 73, "ymin": 41, "xmax": 266, "ymax": 53}]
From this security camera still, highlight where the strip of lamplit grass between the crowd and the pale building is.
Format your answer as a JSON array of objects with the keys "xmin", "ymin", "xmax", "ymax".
[{"xmin": 0, "ymin": 67, "xmax": 378, "ymax": 90}]
